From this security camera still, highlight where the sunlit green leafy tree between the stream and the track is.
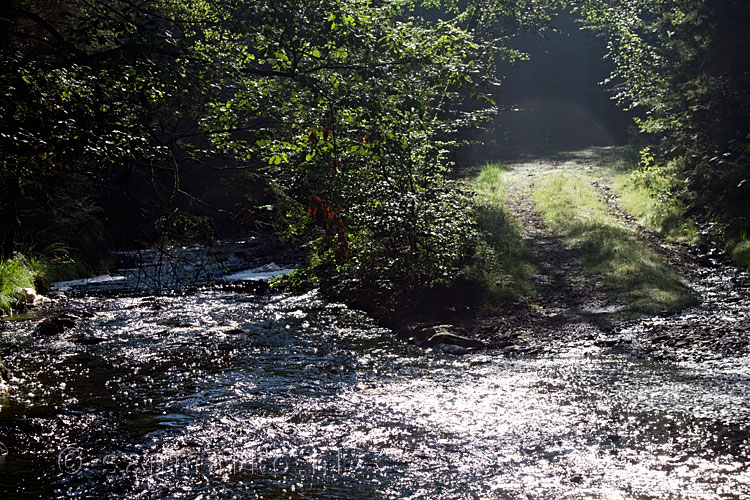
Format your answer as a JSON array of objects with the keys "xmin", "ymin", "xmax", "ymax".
[{"xmin": 199, "ymin": 0, "xmax": 556, "ymax": 304}]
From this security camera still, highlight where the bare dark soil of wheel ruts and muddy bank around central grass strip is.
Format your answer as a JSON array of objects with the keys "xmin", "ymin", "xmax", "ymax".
[{"xmin": 471, "ymin": 149, "xmax": 750, "ymax": 362}]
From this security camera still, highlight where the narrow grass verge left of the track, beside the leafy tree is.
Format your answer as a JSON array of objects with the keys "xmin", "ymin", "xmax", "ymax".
[{"xmin": 465, "ymin": 163, "xmax": 536, "ymax": 310}]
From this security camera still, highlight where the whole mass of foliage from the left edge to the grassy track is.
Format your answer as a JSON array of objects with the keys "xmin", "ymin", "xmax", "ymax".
[{"xmin": 0, "ymin": 0, "xmax": 558, "ymax": 306}]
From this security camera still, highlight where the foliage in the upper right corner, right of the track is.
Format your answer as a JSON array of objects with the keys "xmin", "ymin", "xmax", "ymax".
[{"xmin": 579, "ymin": 0, "xmax": 750, "ymax": 244}]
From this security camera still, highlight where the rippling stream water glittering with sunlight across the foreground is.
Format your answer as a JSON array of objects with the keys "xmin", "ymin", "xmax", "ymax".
[{"xmin": 0, "ymin": 290, "xmax": 750, "ymax": 499}]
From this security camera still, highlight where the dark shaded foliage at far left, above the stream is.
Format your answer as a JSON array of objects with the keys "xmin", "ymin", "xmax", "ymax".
[{"xmin": 0, "ymin": 0, "xmax": 232, "ymax": 263}]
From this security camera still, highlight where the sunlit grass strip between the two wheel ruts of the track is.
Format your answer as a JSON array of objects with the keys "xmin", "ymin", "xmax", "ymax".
[{"xmin": 533, "ymin": 172, "xmax": 695, "ymax": 314}]
